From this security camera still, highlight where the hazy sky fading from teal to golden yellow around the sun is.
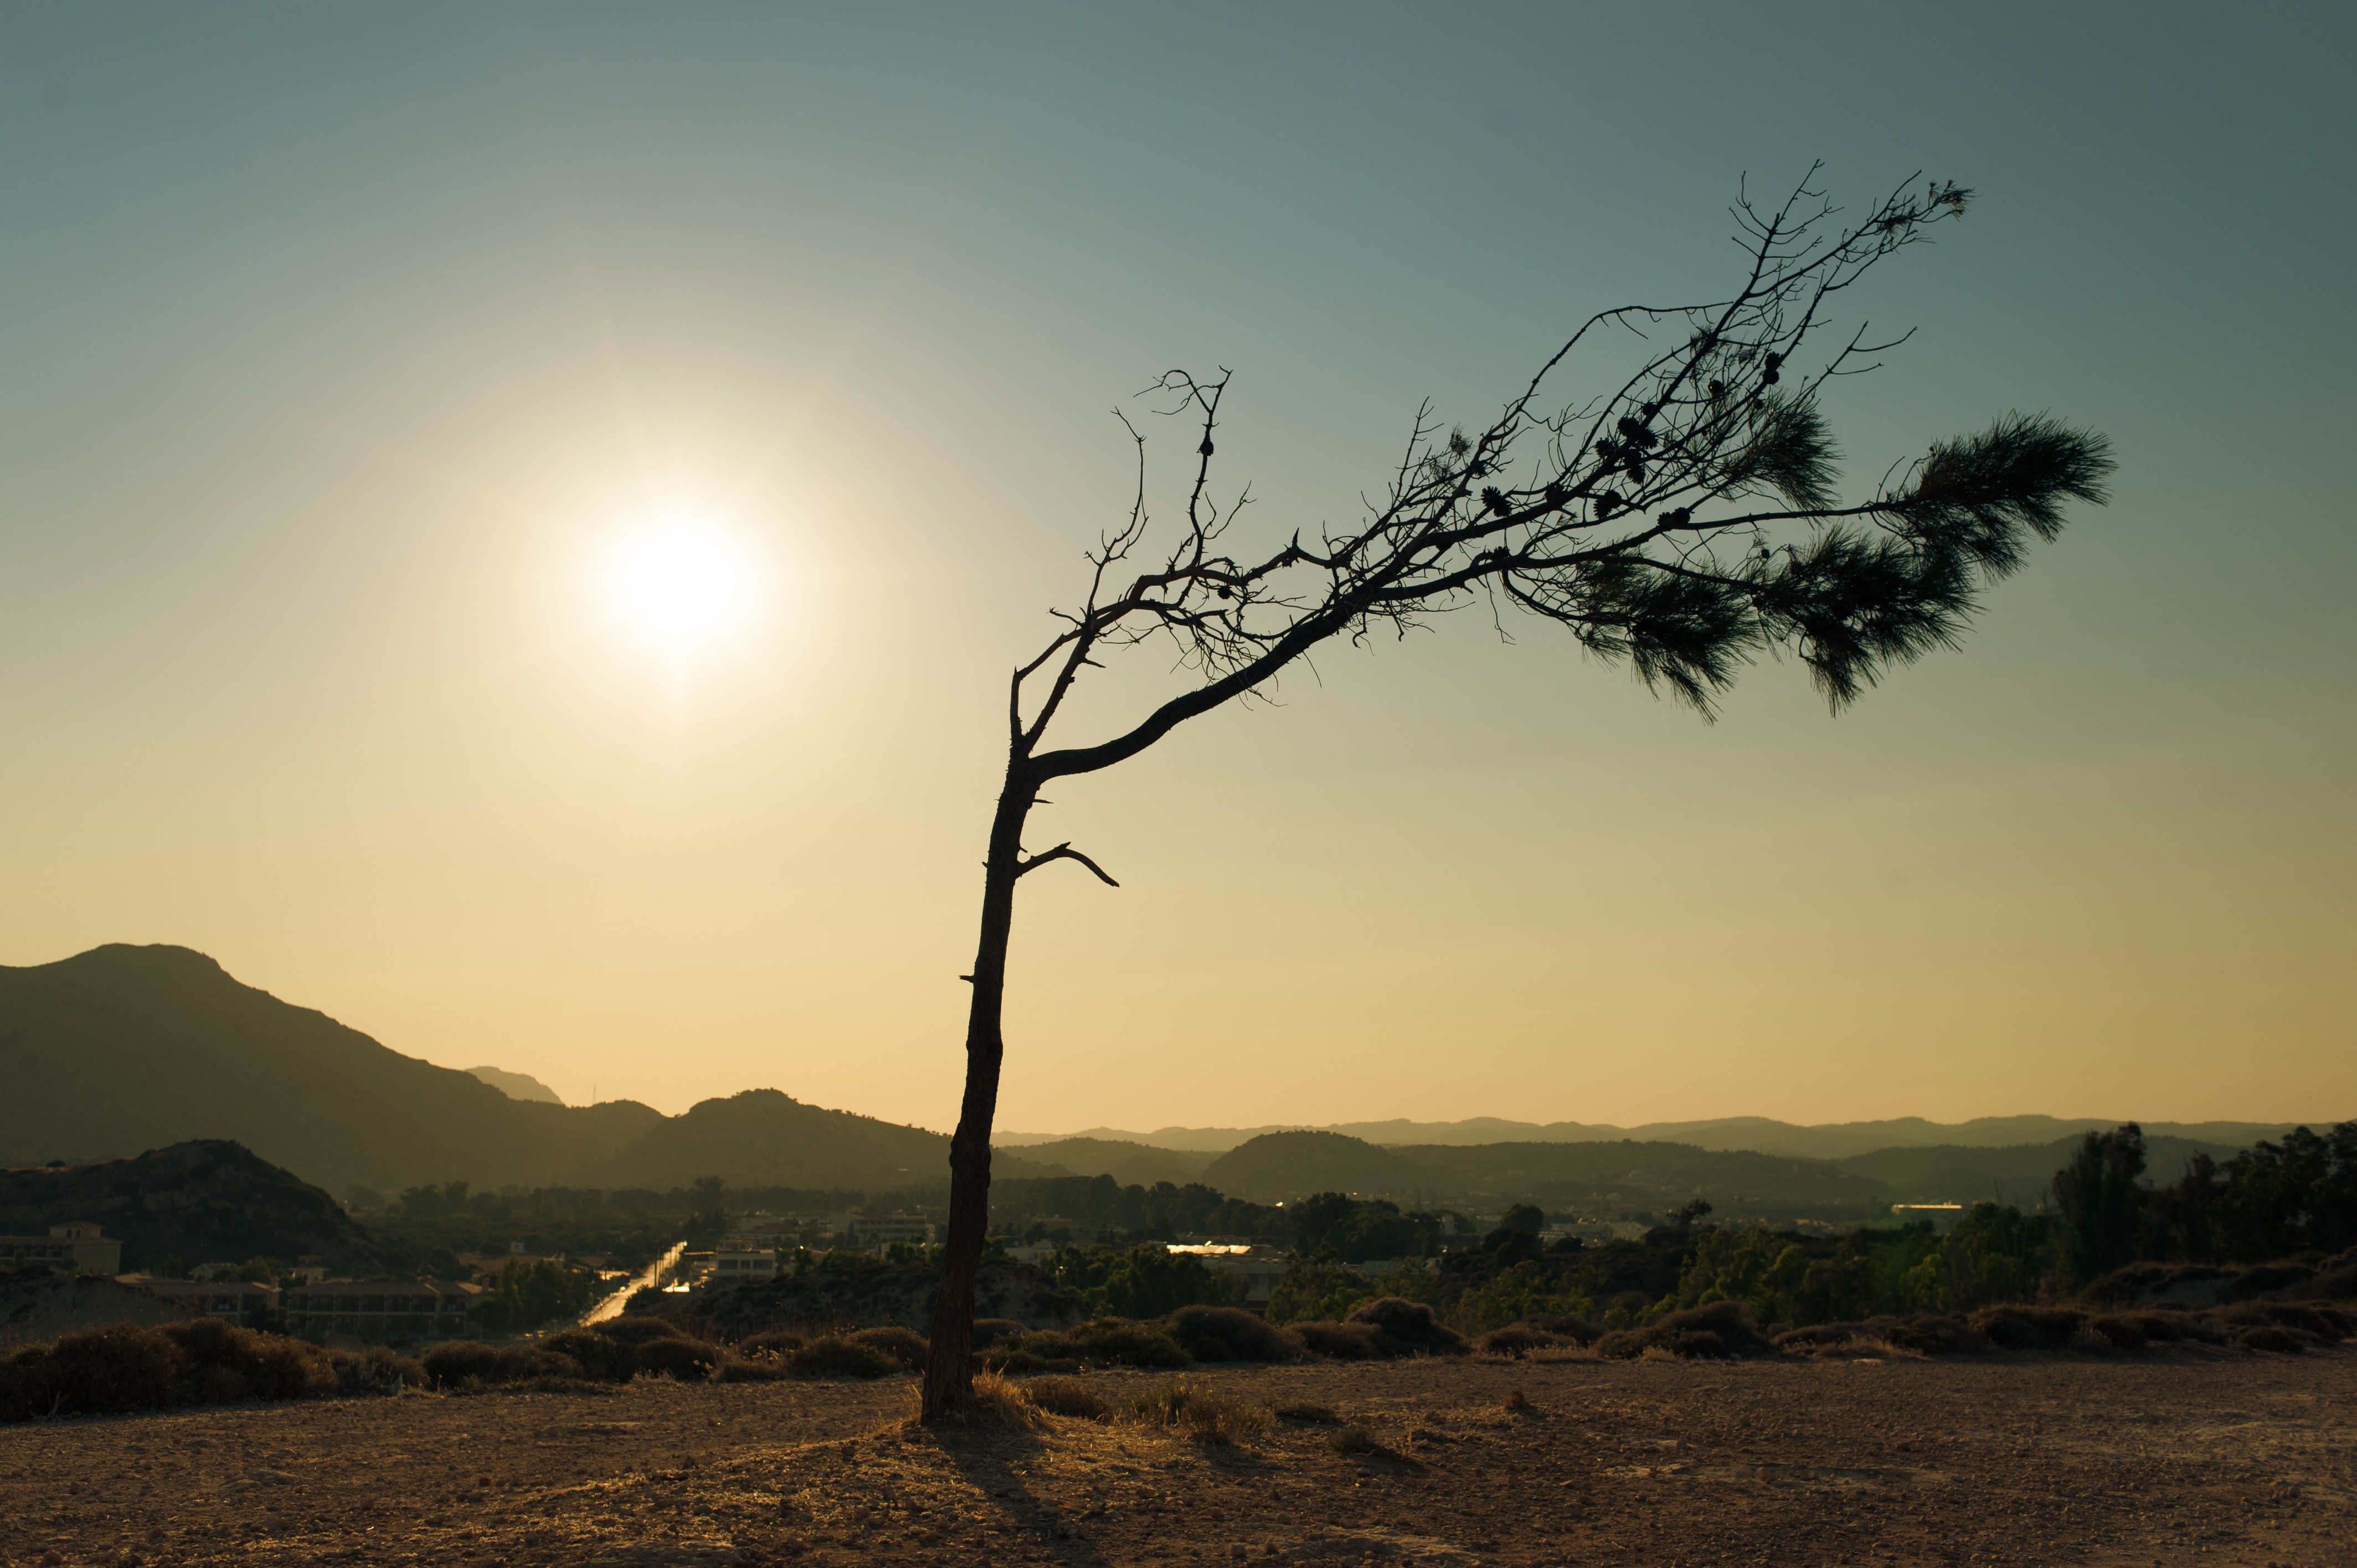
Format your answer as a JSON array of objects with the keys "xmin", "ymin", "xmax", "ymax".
[{"xmin": 0, "ymin": 0, "xmax": 2357, "ymax": 1129}]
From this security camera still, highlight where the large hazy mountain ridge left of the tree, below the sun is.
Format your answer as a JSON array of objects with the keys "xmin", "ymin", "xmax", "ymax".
[{"xmin": 0, "ymin": 943, "xmax": 1013, "ymax": 1193}]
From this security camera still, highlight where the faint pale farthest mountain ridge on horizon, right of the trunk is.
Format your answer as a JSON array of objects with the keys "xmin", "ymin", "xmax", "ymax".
[{"xmin": 992, "ymin": 1115, "xmax": 2338, "ymax": 1160}]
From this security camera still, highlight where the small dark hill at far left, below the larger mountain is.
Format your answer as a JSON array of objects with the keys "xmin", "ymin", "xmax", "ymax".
[{"xmin": 0, "ymin": 1139, "xmax": 382, "ymax": 1276}]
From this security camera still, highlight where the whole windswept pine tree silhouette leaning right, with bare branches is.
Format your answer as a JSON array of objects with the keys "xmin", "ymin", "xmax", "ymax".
[{"xmin": 924, "ymin": 170, "xmax": 2112, "ymax": 1420}]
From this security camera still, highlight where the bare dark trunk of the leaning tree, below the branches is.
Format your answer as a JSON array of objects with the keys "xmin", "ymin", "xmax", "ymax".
[{"xmin": 922, "ymin": 757, "xmax": 1035, "ymax": 1422}]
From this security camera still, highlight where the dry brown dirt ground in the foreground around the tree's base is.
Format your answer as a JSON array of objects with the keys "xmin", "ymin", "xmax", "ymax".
[{"xmin": 0, "ymin": 1351, "xmax": 2357, "ymax": 1568}]
